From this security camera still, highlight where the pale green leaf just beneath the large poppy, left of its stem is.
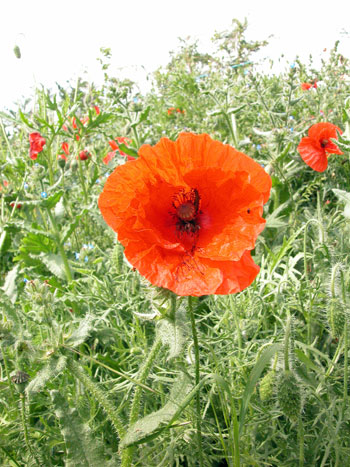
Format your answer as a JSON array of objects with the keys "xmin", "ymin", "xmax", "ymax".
[{"xmin": 157, "ymin": 312, "xmax": 189, "ymax": 359}]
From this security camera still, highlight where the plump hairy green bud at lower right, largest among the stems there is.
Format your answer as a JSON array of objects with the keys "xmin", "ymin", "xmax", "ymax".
[{"xmin": 277, "ymin": 370, "xmax": 301, "ymax": 421}]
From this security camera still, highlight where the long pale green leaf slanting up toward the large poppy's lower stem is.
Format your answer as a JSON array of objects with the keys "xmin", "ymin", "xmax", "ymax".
[{"xmin": 121, "ymin": 373, "xmax": 192, "ymax": 446}]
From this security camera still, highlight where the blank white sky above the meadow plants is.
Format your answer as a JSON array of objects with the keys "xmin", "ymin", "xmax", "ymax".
[{"xmin": 0, "ymin": 0, "xmax": 350, "ymax": 109}]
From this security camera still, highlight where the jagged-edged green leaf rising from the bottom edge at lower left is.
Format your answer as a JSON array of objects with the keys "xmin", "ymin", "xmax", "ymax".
[{"xmin": 50, "ymin": 391, "xmax": 117, "ymax": 467}]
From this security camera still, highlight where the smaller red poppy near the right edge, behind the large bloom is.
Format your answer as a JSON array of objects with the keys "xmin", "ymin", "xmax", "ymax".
[{"xmin": 298, "ymin": 122, "xmax": 343, "ymax": 172}]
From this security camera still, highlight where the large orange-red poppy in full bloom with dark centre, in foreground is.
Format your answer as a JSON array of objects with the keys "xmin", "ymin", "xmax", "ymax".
[{"xmin": 99, "ymin": 133, "xmax": 271, "ymax": 296}]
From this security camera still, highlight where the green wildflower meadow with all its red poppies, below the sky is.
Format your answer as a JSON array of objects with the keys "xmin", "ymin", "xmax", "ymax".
[{"xmin": 0, "ymin": 20, "xmax": 350, "ymax": 467}]
